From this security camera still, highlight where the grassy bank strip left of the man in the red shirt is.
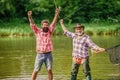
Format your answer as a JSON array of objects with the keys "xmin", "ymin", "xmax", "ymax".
[{"xmin": 0, "ymin": 19, "xmax": 33, "ymax": 36}]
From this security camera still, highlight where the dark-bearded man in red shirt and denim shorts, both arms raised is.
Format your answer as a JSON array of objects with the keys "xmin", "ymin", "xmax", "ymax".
[{"xmin": 28, "ymin": 8, "xmax": 60, "ymax": 80}]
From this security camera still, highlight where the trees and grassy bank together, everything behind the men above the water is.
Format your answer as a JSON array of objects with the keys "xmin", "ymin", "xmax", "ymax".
[{"xmin": 0, "ymin": 0, "xmax": 120, "ymax": 36}]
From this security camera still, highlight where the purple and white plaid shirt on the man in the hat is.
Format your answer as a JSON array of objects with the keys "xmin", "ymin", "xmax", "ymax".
[{"xmin": 64, "ymin": 31, "xmax": 99, "ymax": 58}]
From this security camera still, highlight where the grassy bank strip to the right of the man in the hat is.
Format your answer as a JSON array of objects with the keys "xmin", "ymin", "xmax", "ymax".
[{"xmin": 85, "ymin": 22, "xmax": 120, "ymax": 35}]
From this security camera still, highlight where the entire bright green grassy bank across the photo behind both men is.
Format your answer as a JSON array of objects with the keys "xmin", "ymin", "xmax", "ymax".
[{"xmin": 0, "ymin": 19, "xmax": 120, "ymax": 37}]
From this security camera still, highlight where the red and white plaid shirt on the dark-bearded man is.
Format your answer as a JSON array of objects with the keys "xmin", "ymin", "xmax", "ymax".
[{"xmin": 30, "ymin": 23, "xmax": 55, "ymax": 52}]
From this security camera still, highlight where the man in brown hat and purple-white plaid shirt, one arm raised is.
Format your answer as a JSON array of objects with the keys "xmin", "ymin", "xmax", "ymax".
[{"xmin": 60, "ymin": 19, "xmax": 105, "ymax": 80}]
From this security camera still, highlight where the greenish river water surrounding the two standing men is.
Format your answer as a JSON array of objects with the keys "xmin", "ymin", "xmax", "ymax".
[{"xmin": 0, "ymin": 36, "xmax": 120, "ymax": 80}]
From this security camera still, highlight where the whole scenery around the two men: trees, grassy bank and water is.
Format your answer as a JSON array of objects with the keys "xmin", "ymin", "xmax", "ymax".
[{"xmin": 0, "ymin": 0, "xmax": 120, "ymax": 80}]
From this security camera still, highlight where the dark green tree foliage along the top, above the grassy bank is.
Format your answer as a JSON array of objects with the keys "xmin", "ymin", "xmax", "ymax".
[{"xmin": 0, "ymin": 0, "xmax": 120, "ymax": 23}]
